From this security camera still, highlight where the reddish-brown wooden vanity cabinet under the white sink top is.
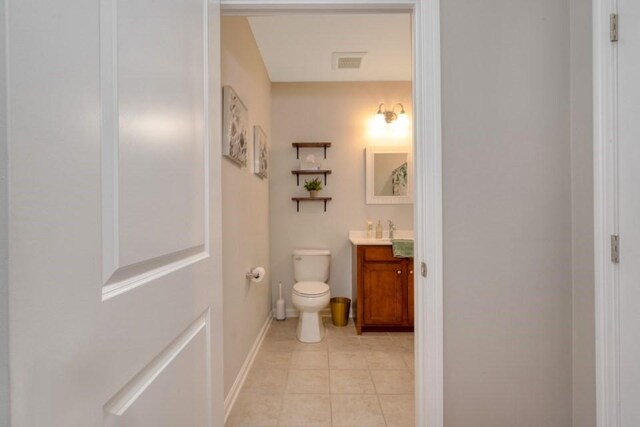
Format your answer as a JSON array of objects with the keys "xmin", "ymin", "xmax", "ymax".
[{"xmin": 353, "ymin": 245, "xmax": 413, "ymax": 334}]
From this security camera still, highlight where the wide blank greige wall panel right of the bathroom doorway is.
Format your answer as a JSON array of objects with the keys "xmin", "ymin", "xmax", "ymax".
[{"xmin": 441, "ymin": 0, "xmax": 572, "ymax": 427}]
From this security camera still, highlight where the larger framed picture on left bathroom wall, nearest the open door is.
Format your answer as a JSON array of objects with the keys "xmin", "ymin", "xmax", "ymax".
[{"xmin": 222, "ymin": 86, "xmax": 249, "ymax": 166}]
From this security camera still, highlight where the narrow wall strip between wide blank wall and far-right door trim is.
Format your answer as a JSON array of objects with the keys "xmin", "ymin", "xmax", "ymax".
[{"xmin": 570, "ymin": 0, "xmax": 596, "ymax": 427}]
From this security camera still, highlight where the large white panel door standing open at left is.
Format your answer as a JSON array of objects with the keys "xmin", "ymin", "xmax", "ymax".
[{"xmin": 7, "ymin": 0, "xmax": 222, "ymax": 427}]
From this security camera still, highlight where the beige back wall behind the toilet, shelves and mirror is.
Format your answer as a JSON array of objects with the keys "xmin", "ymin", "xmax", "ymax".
[{"xmin": 270, "ymin": 82, "xmax": 413, "ymax": 309}]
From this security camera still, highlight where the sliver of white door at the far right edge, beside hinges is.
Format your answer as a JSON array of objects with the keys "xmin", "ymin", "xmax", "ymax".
[{"xmin": 617, "ymin": 0, "xmax": 640, "ymax": 427}]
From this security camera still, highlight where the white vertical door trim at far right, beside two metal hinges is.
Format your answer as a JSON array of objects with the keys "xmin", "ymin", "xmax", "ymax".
[{"xmin": 593, "ymin": 0, "xmax": 620, "ymax": 427}]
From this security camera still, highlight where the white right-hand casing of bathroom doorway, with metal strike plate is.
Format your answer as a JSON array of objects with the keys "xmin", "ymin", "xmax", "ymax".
[{"xmin": 413, "ymin": 0, "xmax": 444, "ymax": 427}]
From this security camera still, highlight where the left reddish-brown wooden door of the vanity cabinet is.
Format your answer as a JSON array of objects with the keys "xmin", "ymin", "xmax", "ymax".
[{"xmin": 363, "ymin": 262, "xmax": 406, "ymax": 325}]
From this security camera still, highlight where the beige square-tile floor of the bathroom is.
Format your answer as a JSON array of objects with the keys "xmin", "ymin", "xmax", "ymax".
[{"xmin": 226, "ymin": 318, "xmax": 414, "ymax": 427}]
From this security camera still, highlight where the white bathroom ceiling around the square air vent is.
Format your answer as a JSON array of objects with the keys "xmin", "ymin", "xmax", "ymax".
[{"xmin": 248, "ymin": 14, "xmax": 411, "ymax": 82}]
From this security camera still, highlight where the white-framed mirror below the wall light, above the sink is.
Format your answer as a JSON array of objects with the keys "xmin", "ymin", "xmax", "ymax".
[{"xmin": 366, "ymin": 145, "xmax": 413, "ymax": 205}]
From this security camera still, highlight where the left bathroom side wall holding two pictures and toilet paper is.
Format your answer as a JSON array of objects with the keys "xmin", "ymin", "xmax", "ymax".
[{"xmin": 221, "ymin": 17, "xmax": 271, "ymax": 394}]
